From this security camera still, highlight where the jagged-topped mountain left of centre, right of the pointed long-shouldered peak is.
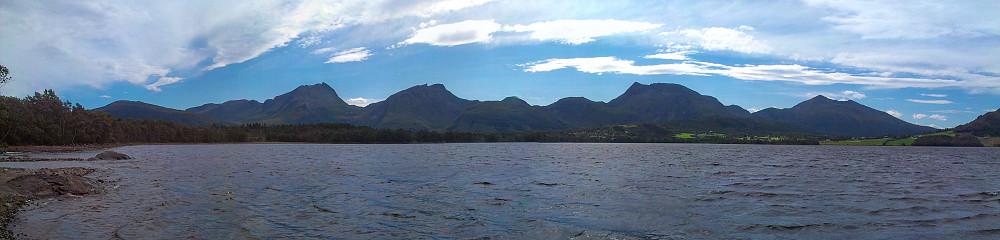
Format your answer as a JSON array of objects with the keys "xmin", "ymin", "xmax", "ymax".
[{"xmin": 356, "ymin": 84, "xmax": 476, "ymax": 130}]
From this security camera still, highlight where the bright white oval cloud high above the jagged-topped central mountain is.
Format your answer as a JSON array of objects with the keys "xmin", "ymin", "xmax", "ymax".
[{"xmin": 397, "ymin": 20, "xmax": 501, "ymax": 46}]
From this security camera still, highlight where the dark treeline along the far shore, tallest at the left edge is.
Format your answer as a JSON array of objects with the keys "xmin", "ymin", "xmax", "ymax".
[{"xmin": 0, "ymin": 90, "xmax": 818, "ymax": 146}]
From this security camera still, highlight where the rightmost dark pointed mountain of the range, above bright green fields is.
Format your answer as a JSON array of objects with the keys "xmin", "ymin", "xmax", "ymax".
[{"xmin": 752, "ymin": 95, "xmax": 935, "ymax": 137}]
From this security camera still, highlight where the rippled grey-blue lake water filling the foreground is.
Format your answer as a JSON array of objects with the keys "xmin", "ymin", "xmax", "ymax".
[{"xmin": 0, "ymin": 143, "xmax": 1000, "ymax": 239}]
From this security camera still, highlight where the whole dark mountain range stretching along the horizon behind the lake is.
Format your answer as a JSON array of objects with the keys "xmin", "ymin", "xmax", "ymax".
[{"xmin": 97, "ymin": 83, "xmax": 935, "ymax": 137}]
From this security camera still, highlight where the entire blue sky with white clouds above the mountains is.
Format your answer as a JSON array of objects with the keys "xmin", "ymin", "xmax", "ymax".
[{"xmin": 0, "ymin": 0, "xmax": 1000, "ymax": 128}]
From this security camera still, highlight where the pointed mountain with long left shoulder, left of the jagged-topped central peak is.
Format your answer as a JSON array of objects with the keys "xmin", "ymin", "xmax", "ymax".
[{"xmin": 187, "ymin": 83, "xmax": 361, "ymax": 124}]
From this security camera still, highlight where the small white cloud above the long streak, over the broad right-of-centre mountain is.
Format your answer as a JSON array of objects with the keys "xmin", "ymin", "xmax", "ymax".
[{"xmin": 660, "ymin": 26, "xmax": 771, "ymax": 53}]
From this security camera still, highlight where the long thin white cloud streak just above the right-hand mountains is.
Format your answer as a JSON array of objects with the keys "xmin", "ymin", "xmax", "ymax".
[{"xmin": 522, "ymin": 57, "xmax": 961, "ymax": 89}]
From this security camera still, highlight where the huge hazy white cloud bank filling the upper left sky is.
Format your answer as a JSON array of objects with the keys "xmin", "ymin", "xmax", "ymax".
[{"xmin": 0, "ymin": 0, "xmax": 490, "ymax": 94}]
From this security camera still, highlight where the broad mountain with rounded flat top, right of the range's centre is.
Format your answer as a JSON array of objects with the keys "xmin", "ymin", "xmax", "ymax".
[{"xmin": 608, "ymin": 82, "xmax": 750, "ymax": 122}]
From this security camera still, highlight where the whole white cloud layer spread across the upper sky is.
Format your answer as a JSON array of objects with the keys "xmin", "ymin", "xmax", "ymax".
[{"xmin": 0, "ymin": 0, "xmax": 1000, "ymax": 101}]
